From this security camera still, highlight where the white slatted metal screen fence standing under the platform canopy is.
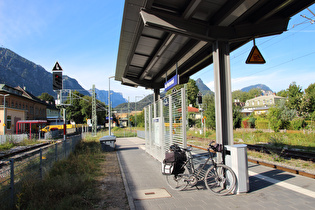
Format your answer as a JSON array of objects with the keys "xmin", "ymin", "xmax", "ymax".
[{"xmin": 144, "ymin": 88, "xmax": 187, "ymax": 161}]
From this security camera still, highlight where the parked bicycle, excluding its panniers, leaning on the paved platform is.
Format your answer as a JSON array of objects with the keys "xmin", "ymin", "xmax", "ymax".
[{"xmin": 166, "ymin": 142, "xmax": 236, "ymax": 195}]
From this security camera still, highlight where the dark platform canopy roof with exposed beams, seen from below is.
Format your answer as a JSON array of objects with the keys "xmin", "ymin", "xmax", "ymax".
[{"xmin": 115, "ymin": 0, "xmax": 315, "ymax": 89}]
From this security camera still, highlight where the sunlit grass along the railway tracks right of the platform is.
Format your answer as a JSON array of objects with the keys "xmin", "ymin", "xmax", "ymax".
[{"xmin": 187, "ymin": 130, "xmax": 315, "ymax": 174}]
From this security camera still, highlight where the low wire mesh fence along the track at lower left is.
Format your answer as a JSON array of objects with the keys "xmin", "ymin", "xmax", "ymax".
[{"xmin": 0, "ymin": 135, "xmax": 81, "ymax": 209}]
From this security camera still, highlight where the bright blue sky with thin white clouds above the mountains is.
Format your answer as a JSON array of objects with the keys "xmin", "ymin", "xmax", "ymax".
[{"xmin": 0, "ymin": 0, "xmax": 315, "ymax": 101}]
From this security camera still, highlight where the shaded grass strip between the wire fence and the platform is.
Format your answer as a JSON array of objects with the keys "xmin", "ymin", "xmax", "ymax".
[{"xmin": 17, "ymin": 137, "xmax": 106, "ymax": 209}]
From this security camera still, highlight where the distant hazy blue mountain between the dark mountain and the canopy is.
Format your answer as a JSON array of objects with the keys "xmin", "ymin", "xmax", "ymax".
[{"xmin": 89, "ymin": 88, "xmax": 128, "ymax": 108}]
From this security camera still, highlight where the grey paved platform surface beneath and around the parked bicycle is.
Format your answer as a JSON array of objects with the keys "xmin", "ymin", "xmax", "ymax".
[{"xmin": 116, "ymin": 137, "xmax": 315, "ymax": 210}]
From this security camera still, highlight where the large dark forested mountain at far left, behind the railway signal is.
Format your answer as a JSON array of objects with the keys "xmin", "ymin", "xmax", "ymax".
[{"xmin": 0, "ymin": 48, "xmax": 89, "ymax": 96}]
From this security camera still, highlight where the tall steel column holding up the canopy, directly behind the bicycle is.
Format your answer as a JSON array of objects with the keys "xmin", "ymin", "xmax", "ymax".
[{"xmin": 213, "ymin": 41, "xmax": 233, "ymax": 159}]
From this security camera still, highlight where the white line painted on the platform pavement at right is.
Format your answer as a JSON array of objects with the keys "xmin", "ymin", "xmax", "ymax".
[{"xmin": 248, "ymin": 171, "xmax": 315, "ymax": 198}]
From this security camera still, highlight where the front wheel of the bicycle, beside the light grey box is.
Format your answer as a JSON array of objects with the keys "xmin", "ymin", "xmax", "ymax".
[{"xmin": 204, "ymin": 164, "xmax": 236, "ymax": 195}]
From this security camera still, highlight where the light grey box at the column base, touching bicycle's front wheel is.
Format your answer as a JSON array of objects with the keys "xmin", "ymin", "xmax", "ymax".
[{"xmin": 225, "ymin": 144, "xmax": 249, "ymax": 194}]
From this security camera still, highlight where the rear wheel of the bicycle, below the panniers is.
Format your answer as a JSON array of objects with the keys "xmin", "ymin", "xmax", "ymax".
[{"xmin": 165, "ymin": 166, "xmax": 189, "ymax": 190}]
